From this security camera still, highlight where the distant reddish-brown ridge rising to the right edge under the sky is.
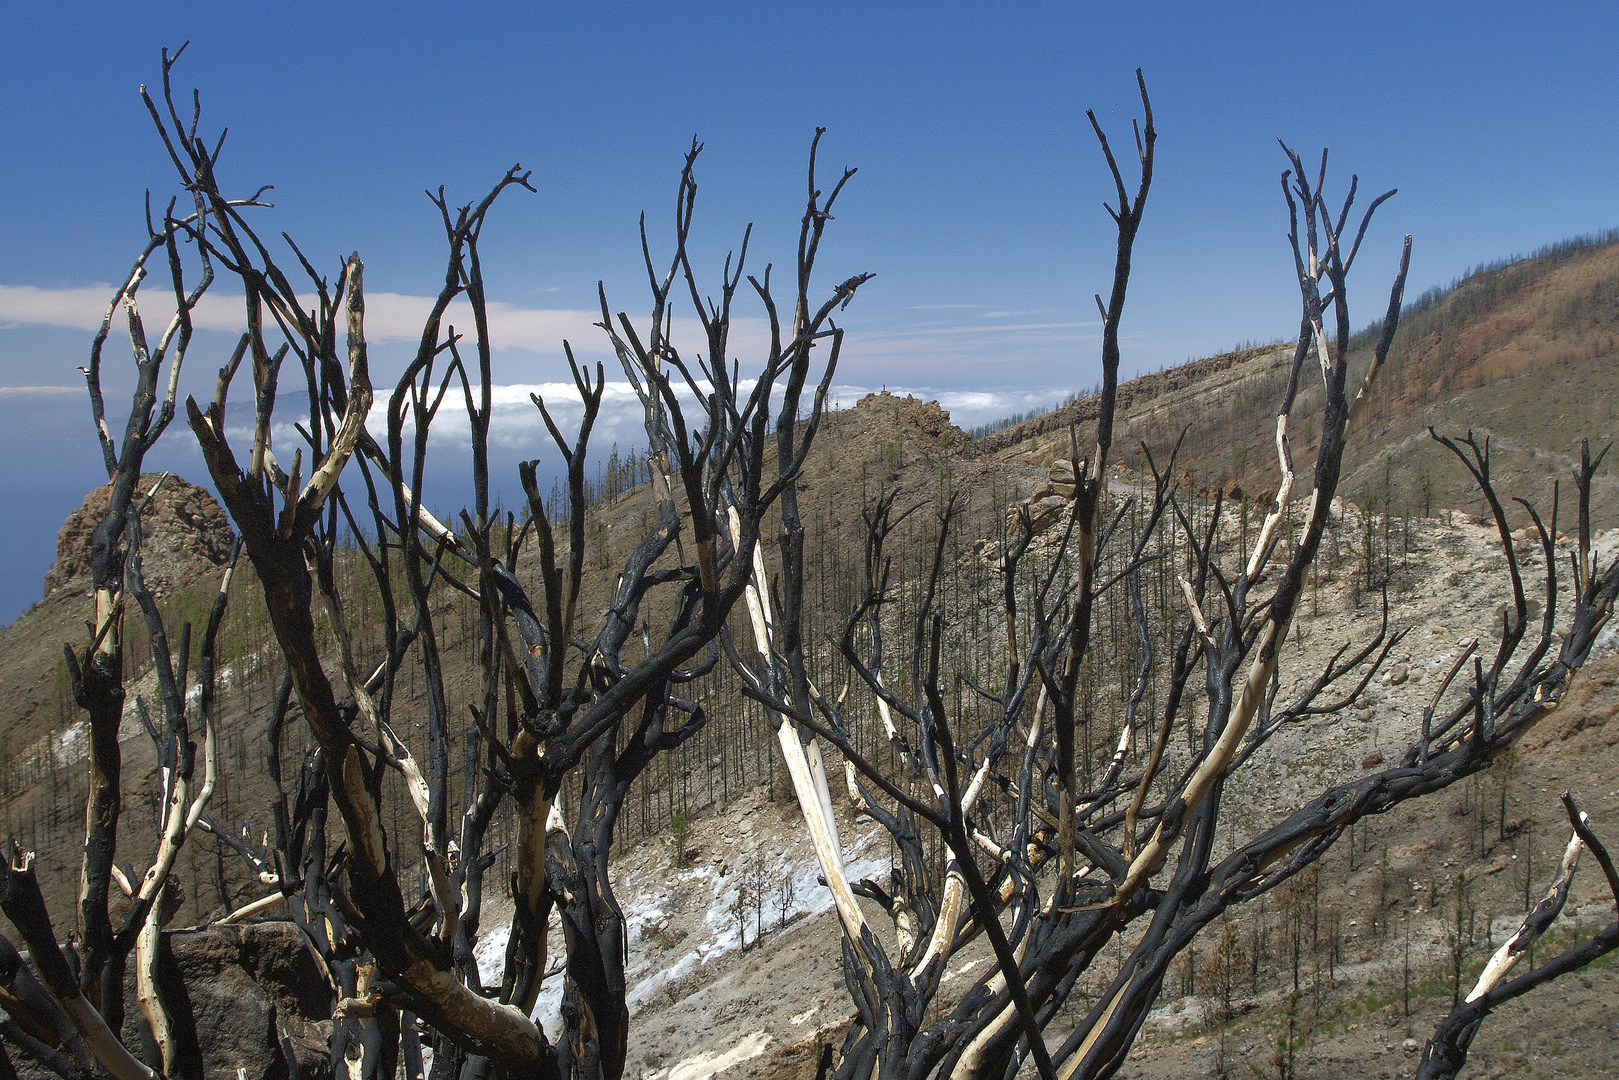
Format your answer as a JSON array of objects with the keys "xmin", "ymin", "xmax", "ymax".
[{"xmin": 978, "ymin": 236, "xmax": 1619, "ymax": 534}]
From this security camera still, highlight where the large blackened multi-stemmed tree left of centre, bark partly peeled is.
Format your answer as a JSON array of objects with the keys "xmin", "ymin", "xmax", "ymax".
[{"xmin": 185, "ymin": 86, "xmax": 865, "ymax": 1077}]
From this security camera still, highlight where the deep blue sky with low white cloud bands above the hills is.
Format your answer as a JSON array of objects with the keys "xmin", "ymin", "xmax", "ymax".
[{"xmin": 0, "ymin": 3, "xmax": 1619, "ymax": 619}]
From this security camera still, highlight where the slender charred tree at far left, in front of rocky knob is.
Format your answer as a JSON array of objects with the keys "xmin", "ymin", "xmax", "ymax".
[{"xmin": 0, "ymin": 132, "xmax": 246, "ymax": 1080}]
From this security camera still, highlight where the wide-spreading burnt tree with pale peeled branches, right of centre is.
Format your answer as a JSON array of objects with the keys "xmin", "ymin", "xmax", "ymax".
[{"xmin": 732, "ymin": 71, "xmax": 1619, "ymax": 1080}]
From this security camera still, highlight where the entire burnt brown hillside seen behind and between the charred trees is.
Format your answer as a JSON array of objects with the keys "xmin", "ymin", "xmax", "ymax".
[{"xmin": 0, "ymin": 243, "xmax": 1619, "ymax": 1080}]
